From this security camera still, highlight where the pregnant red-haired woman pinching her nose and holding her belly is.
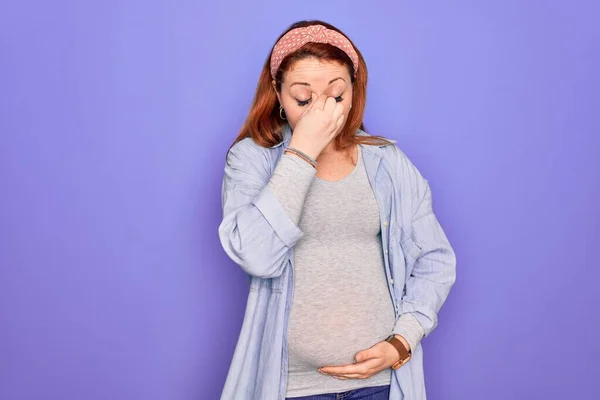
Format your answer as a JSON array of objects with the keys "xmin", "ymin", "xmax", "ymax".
[{"xmin": 219, "ymin": 21, "xmax": 456, "ymax": 400}]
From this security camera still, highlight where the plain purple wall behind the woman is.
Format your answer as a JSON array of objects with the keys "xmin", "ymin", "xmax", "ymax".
[{"xmin": 0, "ymin": 0, "xmax": 600, "ymax": 400}]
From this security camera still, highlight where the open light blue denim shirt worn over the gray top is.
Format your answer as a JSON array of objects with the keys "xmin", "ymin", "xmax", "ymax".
[{"xmin": 219, "ymin": 125, "xmax": 456, "ymax": 400}]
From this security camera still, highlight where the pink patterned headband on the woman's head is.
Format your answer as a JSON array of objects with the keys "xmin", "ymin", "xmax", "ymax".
[{"xmin": 271, "ymin": 25, "xmax": 358, "ymax": 79}]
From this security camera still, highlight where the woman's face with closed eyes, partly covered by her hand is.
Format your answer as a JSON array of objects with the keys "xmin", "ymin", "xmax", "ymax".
[{"xmin": 273, "ymin": 58, "xmax": 352, "ymax": 129}]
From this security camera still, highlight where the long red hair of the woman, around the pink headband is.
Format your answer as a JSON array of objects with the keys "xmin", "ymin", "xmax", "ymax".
[{"xmin": 232, "ymin": 20, "xmax": 392, "ymax": 151}]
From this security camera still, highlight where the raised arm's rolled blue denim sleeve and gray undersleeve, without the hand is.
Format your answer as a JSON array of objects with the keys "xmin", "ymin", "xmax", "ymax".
[{"xmin": 219, "ymin": 143, "xmax": 316, "ymax": 278}]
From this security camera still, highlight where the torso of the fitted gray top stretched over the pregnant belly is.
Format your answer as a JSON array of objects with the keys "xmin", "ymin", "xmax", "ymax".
[{"xmin": 280, "ymin": 146, "xmax": 395, "ymax": 397}]
